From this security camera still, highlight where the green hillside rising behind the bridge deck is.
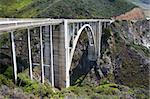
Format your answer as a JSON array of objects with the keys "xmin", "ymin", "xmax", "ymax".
[{"xmin": 0, "ymin": 0, "xmax": 135, "ymax": 18}]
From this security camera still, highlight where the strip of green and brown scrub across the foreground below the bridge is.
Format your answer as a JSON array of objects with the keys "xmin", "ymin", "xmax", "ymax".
[{"xmin": 0, "ymin": 69, "xmax": 148, "ymax": 99}]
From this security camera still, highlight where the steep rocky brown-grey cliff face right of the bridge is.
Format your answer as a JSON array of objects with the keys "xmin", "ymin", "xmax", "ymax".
[{"xmin": 102, "ymin": 20, "xmax": 150, "ymax": 89}]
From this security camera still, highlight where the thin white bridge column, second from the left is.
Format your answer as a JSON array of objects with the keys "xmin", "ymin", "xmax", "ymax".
[{"xmin": 27, "ymin": 28, "xmax": 33, "ymax": 80}]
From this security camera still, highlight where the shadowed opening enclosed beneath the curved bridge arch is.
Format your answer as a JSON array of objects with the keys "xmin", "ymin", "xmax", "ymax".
[{"xmin": 69, "ymin": 26, "xmax": 96, "ymax": 85}]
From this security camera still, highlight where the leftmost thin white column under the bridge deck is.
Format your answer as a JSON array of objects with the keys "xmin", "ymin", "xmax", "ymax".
[{"xmin": 10, "ymin": 31, "xmax": 17, "ymax": 83}]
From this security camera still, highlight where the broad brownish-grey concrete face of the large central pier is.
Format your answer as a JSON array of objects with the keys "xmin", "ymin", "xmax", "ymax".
[{"xmin": 53, "ymin": 24, "xmax": 66, "ymax": 88}]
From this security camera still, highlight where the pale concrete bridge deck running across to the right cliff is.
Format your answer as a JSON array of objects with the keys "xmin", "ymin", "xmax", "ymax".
[{"xmin": 0, "ymin": 18, "xmax": 112, "ymax": 34}]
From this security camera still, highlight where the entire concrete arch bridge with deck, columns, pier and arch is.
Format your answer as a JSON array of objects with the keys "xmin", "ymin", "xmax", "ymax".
[{"xmin": 0, "ymin": 18, "xmax": 113, "ymax": 87}]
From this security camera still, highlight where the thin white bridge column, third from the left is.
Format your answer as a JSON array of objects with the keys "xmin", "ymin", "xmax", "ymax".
[{"xmin": 40, "ymin": 26, "xmax": 44, "ymax": 83}]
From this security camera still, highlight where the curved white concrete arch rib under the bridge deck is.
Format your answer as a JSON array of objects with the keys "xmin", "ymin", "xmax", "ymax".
[{"xmin": 69, "ymin": 24, "xmax": 96, "ymax": 70}]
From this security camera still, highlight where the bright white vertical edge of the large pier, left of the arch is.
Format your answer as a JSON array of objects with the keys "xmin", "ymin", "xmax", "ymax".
[{"xmin": 64, "ymin": 20, "xmax": 70, "ymax": 87}]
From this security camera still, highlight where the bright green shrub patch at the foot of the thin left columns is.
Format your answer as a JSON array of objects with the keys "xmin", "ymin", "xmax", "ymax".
[{"xmin": 18, "ymin": 73, "xmax": 53, "ymax": 98}]
